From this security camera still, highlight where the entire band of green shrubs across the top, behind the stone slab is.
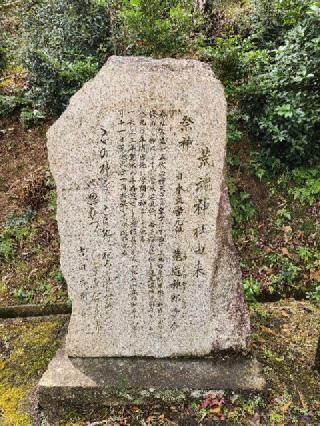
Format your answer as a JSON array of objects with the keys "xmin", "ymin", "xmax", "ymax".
[{"xmin": 5, "ymin": 0, "xmax": 320, "ymax": 171}]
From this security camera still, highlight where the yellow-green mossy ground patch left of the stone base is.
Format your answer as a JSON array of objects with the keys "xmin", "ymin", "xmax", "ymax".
[{"xmin": 0, "ymin": 317, "xmax": 65, "ymax": 426}]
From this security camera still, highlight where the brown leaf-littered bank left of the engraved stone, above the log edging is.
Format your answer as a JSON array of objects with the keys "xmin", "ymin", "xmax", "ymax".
[{"xmin": 0, "ymin": 117, "xmax": 67, "ymax": 306}]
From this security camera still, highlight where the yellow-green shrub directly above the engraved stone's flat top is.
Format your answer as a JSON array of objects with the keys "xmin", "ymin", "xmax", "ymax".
[{"xmin": 113, "ymin": 0, "xmax": 200, "ymax": 57}]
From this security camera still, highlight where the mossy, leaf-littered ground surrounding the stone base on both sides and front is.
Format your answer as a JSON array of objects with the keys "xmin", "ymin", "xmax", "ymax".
[{"xmin": 0, "ymin": 300, "xmax": 320, "ymax": 426}]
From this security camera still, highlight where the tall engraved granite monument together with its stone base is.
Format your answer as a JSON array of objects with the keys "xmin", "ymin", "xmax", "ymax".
[{"xmin": 39, "ymin": 57, "xmax": 264, "ymax": 420}]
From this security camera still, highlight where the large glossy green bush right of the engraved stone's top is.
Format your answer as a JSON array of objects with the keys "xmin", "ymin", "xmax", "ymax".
[{"xmin": 210, "ymin": 0, "xmax": 320, "ymax": 171}]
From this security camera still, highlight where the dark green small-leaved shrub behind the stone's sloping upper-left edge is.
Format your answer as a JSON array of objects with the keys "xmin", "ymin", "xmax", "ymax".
[{"xmin": 21, "ymin": 0, "xmax": 110, "ymax": 114}]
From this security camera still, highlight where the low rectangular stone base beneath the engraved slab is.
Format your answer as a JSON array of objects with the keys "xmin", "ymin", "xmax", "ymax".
[{"xmin": 38, "ymin": 348, "xmax": 265, "ymax": 418}]
